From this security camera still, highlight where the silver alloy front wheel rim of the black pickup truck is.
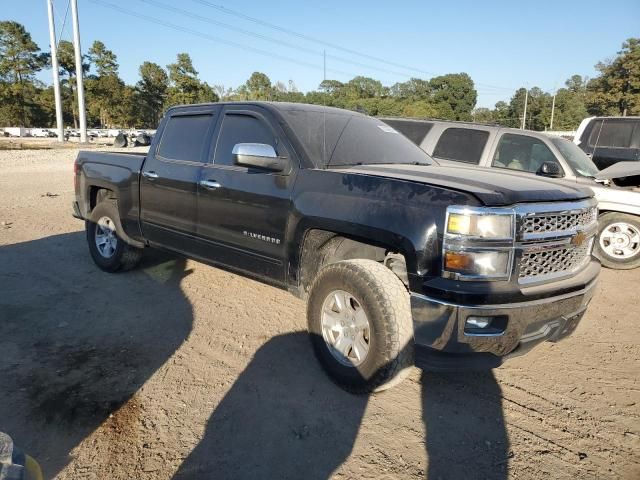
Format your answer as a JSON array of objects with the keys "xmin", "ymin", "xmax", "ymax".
[{"xmin": 321, "ymin": 290, "xmax": 371, "ymax": 367}]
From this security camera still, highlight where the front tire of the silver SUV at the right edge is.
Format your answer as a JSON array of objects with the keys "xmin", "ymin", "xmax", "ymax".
[{"xmin": 593, "ymin": 212, "xmax": 640, "ymax": 270}]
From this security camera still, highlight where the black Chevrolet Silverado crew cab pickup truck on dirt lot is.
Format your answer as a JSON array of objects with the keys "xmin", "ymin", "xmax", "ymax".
[{"xmin": 73, "ymin": 102, "xmax": 600, "ymax": 392}]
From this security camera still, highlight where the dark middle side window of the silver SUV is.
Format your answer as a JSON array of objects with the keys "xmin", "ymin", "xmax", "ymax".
[{"xmin": 433, "ymin": 128, "xmax": 489, "ymax": 165}]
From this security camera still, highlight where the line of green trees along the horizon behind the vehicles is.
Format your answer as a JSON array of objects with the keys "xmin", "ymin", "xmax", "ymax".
[{"xmin": 0, "ymin": 21, "xmax": 640, "ymax": 130}]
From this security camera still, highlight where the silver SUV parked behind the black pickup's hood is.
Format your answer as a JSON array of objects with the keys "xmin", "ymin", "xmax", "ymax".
[{"xmin": 381, "ymin": 118, "xmax": 640, "ymax": 269}]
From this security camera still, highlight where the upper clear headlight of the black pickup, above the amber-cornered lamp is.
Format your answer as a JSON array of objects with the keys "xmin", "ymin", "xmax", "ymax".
[{"xmin": 447, "ymin": 210, "xmax": 513, "ymax": 239}]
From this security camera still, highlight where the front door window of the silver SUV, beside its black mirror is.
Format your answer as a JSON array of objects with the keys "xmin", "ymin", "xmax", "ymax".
[{"xmin": 492, "ymin": 133, "xmax": 563, "ymax": 173}]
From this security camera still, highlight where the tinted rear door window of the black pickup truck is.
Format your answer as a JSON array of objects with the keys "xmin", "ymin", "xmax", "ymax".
[{"xmin": 157, "ymin": 114, "xmax": 213, "ymax": 162}]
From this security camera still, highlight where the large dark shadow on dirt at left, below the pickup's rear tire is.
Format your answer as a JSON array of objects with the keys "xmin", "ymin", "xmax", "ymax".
[{"xmin": 0, "ymin": 232, "xmax": 193, "ymax": 478}]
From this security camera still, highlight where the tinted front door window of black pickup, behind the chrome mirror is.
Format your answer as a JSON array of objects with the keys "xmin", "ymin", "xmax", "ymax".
[{"xmin": 213, "ymin": 112, "xmax": 278, "ymax": 165}]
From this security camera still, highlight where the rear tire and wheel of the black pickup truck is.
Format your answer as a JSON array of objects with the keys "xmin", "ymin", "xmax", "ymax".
[{"xmin": 85, "ymin": 200, "xmax": 142, "ymax": 273}]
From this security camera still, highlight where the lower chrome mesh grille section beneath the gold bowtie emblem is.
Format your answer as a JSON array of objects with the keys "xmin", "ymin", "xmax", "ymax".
[{"xmin": 519, "ymin": 238, "xmax": 593, "ymax": 280}]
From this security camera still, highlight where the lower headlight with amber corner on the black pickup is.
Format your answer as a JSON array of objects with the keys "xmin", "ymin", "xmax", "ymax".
[{"xmin": 444, "ymin": 250, "xmax": 511, "ymax": 278}]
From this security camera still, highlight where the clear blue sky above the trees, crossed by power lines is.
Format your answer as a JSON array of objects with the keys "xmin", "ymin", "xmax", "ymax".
[{"xmin": 5, "ymin": 0, "xmax": 640, "ymax": 107}]
